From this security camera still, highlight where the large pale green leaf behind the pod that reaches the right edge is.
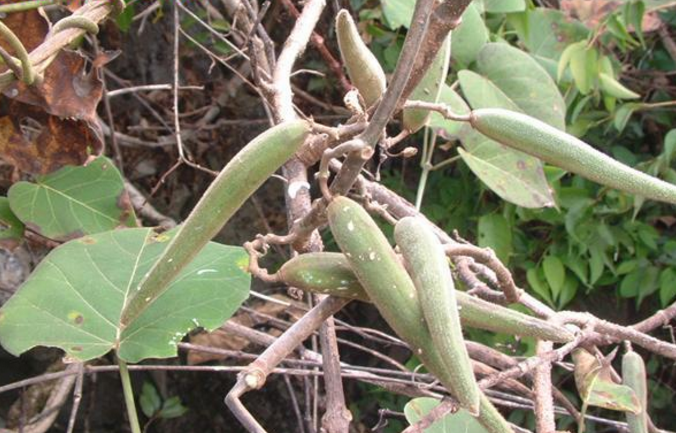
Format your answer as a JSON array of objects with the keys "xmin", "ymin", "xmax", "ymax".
[{"xmin": 458, "ymin": 43, "xmax": 566, "ymax": 208}]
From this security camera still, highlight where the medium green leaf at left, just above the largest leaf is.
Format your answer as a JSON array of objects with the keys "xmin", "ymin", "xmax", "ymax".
[{"xmin": 8, "ymin": 157, "xmax": 136, "ymax": 241}]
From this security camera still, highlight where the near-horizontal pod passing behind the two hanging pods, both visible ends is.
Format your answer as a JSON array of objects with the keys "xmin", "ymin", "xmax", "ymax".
[{"xmin": 277, "ymin": 252, "xmax": 574, "ymax": 343}]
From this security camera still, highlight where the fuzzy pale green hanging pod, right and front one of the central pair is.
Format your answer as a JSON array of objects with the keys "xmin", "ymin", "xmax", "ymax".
[{"xmin": 394, "ymin": 217, "xmax": 481, "ymax": 415}]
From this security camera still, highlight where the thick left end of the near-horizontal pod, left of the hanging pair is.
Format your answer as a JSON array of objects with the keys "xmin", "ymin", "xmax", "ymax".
[{"xmin": 277, "ymin": 253, "xmax": 371, "ymax": 302}]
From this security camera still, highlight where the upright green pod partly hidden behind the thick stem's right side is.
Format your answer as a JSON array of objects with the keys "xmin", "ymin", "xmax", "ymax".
[{"xmin": 403, "ymin": 33, "xmax": 451, "ymax": 133}]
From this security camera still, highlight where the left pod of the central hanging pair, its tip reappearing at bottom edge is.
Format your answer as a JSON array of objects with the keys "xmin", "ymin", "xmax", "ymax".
[{"xmin": 327, "ymin": 197, "xmax": 513, "ymax": 433}]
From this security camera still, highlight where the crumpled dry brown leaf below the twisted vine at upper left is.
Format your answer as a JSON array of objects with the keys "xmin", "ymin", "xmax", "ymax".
[{"xmin": 0, "ymin": 10, "xmax": 107, "ymax": 174}]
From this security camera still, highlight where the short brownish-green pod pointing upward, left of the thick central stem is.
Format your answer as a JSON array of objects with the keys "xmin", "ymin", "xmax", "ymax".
[{"xmin": 336, "ymin": 9, "xmax": 387, "ymax": 107}]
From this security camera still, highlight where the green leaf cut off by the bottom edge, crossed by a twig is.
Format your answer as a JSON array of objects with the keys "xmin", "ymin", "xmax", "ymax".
[{"xmin": 404, "ymin": 397, "xmax": 488, "ymax": 433}]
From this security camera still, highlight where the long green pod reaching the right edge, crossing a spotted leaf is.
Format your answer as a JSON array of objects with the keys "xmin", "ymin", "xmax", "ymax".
[{"xmin": 470, "ymin": 108, "xmax": 676, "ymax": 204}]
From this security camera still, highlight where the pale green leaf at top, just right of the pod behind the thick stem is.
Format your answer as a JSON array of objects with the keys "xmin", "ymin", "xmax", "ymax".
[{"xmin": 451, "ymin": 3, "xmax": 488, "ymax": 66}]
